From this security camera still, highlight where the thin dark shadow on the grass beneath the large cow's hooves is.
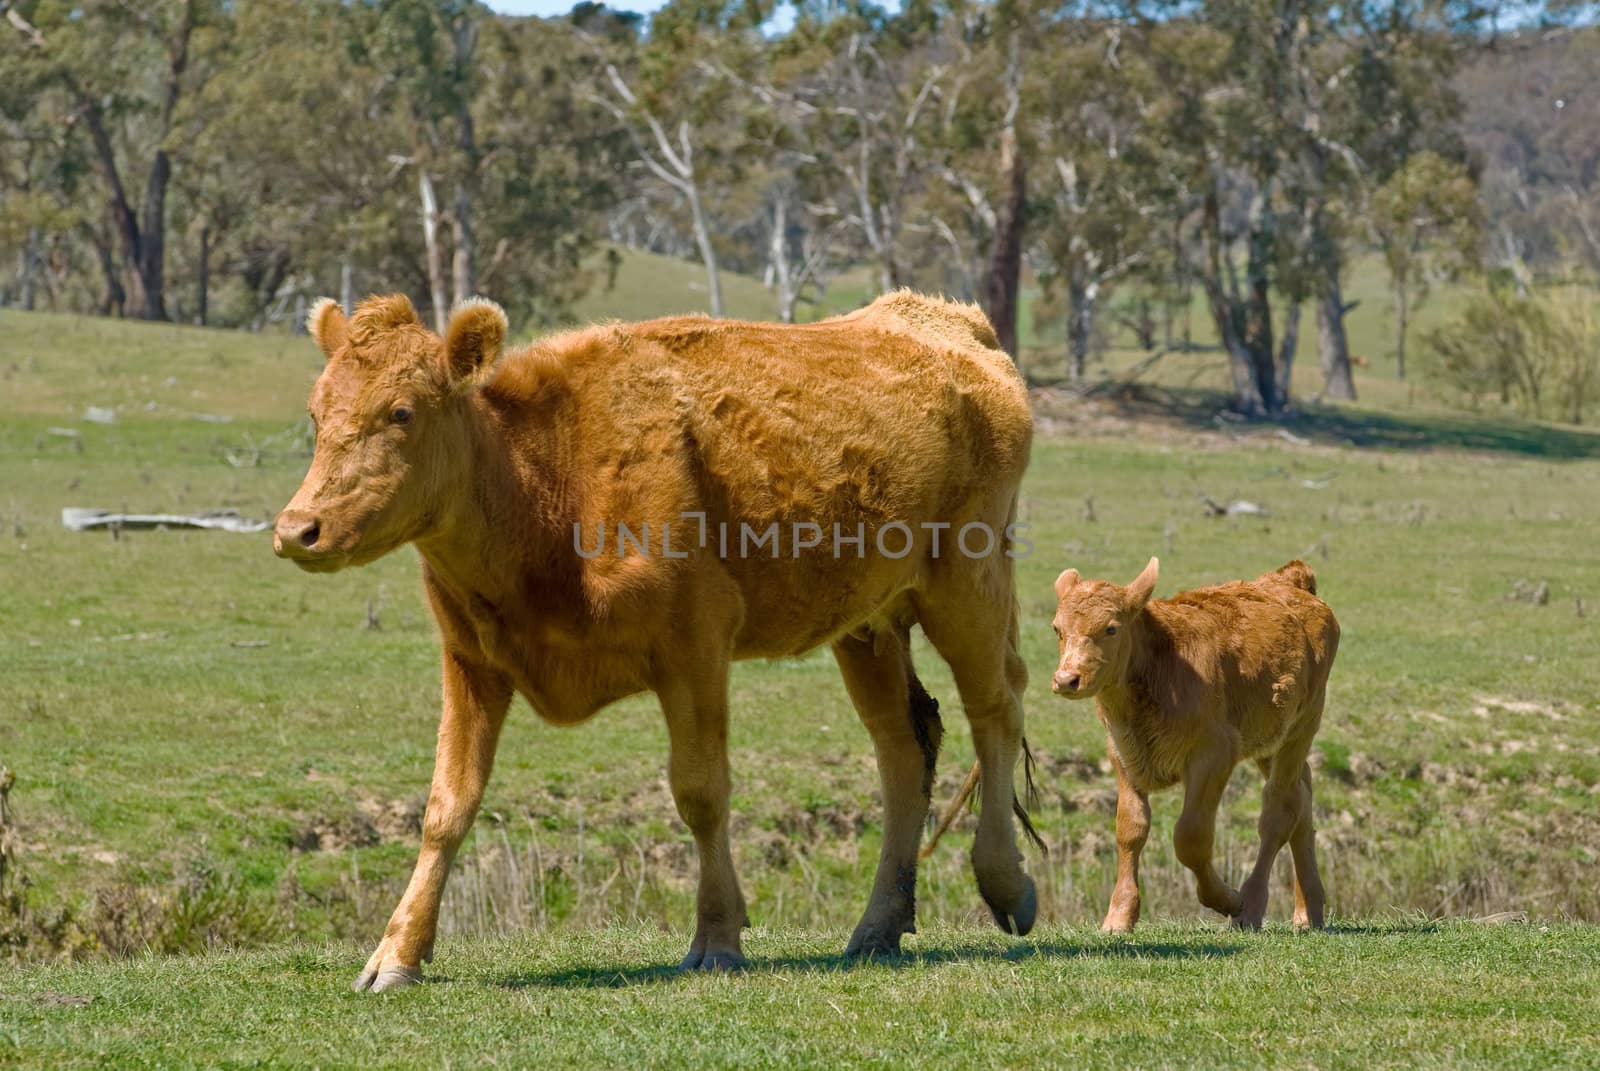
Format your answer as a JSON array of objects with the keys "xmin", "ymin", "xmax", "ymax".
[{"xmin": 496, "ymin": 940, "xmax": 1243, "ymax": 989}]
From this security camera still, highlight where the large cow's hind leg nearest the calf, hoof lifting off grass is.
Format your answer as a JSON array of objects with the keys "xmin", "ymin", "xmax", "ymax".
[{"xmin": 918, "ymin": 576, "xmax": 1038, "ymax": 935}]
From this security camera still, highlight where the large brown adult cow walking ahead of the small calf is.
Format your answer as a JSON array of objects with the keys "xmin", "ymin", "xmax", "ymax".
[{"xmin": 274, "ymin": 291, "xmax": 1037, "ymax": 989}]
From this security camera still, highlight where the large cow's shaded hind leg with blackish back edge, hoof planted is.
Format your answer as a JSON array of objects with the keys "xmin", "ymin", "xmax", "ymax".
[{"xmin": 834, "ymin": 629, "xmax": 944, "ymax": 956}]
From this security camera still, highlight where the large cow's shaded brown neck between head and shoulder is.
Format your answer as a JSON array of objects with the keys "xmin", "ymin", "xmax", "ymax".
[{"xmin": 418, "ymin": 395, "xmax": 574, "ymax": 597}]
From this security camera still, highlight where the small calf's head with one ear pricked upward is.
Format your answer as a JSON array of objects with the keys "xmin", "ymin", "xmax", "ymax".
[{"xmin": 1050, "ymin": 557, "xmax": 1162, "ymax": 700}]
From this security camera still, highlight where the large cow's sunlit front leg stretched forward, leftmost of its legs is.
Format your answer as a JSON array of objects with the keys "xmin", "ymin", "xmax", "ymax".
[{"xmin": 355, "ymin": 653, "xmax": 510, "ymax": 993}]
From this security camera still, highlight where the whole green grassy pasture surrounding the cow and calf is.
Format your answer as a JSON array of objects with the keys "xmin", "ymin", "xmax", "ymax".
[{"xmin": 0, "ymin": 288, "xmax": 1600, "ymax": 1066}]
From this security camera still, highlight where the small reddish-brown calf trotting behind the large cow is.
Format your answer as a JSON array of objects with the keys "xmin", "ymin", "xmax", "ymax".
[{"xmin": 1051, "ymin": 557, "xmax": 1339, "ymax": 933}]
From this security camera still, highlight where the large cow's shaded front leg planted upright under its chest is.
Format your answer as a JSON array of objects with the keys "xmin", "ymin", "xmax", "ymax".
[{"xmin": 658, "ymin": 656, "xmax": 746, "ymax": 970}]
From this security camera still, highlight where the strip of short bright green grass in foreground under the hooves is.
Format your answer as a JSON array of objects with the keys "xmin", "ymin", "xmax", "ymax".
[{"xmin": 0, "ymin": 924, "xmax": 1600, "ymax": 1069}]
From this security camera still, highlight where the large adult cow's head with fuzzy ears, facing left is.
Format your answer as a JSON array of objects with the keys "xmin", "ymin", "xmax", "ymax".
[{"xmin": 272, "ymin": 295, "xmax": 506, "ymax": 572}]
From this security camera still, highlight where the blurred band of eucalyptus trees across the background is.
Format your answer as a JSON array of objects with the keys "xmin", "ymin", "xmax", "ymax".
[{"xmin": 0, "ymin": 0, "xmax": 1600, "ymax": 418}]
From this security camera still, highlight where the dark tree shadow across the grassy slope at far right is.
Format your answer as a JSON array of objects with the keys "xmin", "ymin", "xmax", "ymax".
[{"xmin": 1081, "ymin": 386, "xmax": 1600, "ymax": 459}]
